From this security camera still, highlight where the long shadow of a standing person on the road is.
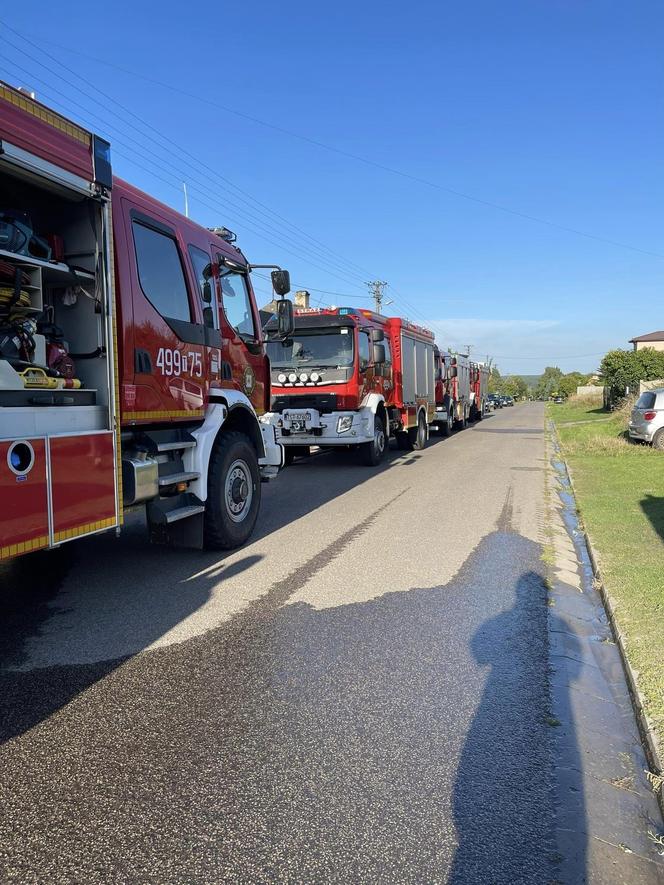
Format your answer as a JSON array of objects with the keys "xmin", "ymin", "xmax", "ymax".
[{"xmin": 449, "ymin": 572, "xmax": 586, "ymax": 885}]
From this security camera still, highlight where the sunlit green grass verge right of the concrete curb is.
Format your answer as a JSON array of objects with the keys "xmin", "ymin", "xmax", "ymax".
[{"xmin": 548, "ymin": 403, "xmax": 664, "ymax": 752}]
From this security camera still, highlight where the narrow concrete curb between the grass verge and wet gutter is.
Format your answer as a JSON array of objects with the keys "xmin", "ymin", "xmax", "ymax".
[{"xmin": 551, "ymin": 421, "xmax": 664, "ymax": 817}]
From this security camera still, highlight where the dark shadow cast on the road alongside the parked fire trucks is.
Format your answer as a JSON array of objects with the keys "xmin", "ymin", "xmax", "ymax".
[{"xmin": 0, "ymin": 436, "xmax": 452, "ymax": 744}]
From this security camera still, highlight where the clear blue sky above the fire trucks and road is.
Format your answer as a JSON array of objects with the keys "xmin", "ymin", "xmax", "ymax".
[{"xmin": 0, "ymin": 0, "xmax": 664, "ymax": 374}]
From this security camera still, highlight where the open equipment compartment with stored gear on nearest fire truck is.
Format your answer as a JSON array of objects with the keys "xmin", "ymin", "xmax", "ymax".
[{"xmin": 0, "ymin": 166, "xmax": 112, "ymax": 424}]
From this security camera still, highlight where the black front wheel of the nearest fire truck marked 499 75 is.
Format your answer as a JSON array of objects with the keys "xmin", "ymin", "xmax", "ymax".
[{"xmin": 204, "ymin": 431, "xmax": 261, "ymax": 550}]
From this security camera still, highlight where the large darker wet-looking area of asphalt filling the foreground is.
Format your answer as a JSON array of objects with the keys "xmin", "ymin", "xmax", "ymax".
[{"xmin": 0, "ymin": 516, "xmax": 583, "ymax": 885}]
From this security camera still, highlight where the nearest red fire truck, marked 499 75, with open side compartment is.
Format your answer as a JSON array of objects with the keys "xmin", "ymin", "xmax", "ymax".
[{"xmin": 0, "ymin": 83, "xmax": 292, "ymax": 559}]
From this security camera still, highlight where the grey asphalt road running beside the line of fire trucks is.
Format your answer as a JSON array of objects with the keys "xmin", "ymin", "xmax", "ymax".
[{"xmin": 0, "ymin": 404, "xmax": 555, "ymax": 885}]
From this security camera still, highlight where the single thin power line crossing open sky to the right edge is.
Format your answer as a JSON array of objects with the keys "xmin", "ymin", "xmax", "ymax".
[{"xmin": 11, "ymin": 23, "xmax": 664, "ymax": 258}]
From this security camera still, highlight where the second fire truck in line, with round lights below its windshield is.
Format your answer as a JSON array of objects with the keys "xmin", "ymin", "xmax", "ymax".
[{"xmin": 266, "ymin": 307, "xmax": 434, "ymax": 465}]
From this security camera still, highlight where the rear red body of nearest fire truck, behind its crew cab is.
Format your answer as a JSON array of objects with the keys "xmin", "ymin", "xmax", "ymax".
[{"xmin": 0, "ymin": 83, "xmax": 121, "ymax": 560}]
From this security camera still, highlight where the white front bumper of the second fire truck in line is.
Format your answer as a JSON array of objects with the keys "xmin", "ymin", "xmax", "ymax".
[{"xmin": 263, "ymin": 409, "xmax": 374, "ymax": 446}]
